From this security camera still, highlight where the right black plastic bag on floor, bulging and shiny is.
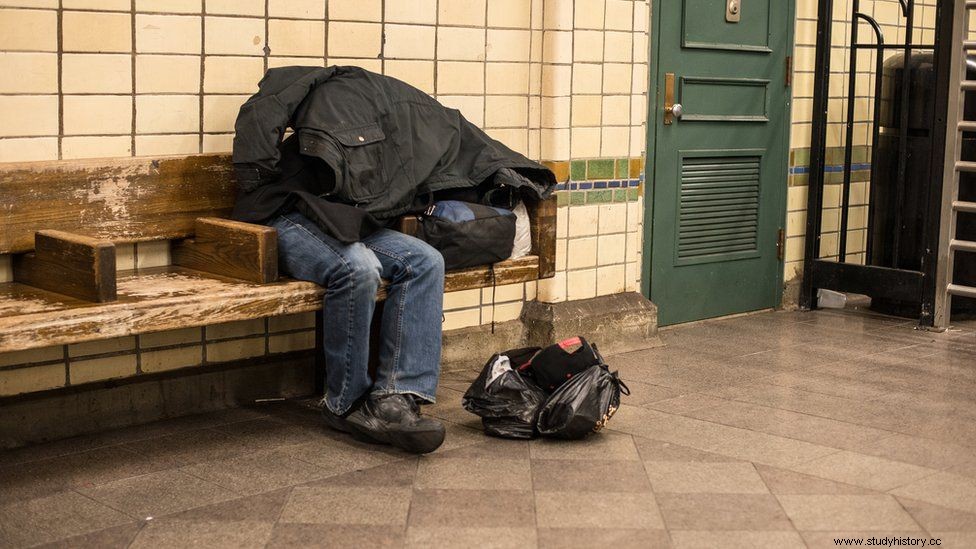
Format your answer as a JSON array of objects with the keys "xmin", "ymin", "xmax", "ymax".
[{"xmin": 537, "ymin": 363, "xmax": 630, "ymax": 439}]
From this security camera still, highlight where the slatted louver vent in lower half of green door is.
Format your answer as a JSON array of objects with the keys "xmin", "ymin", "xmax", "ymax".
[{"xmin": 678, "ymin": 156, "xmax": 761, "ymax": 259}]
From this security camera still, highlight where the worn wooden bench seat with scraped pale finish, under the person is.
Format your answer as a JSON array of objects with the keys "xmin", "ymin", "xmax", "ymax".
[{"xmin": 0, "ymin": 256, "xmax": 539, "ymax": 353}]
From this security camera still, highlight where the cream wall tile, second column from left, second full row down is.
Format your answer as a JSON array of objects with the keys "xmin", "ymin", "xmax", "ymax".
[{"xmin": 61, "ymin": 53, "xmax": 132, "ymax": 93}]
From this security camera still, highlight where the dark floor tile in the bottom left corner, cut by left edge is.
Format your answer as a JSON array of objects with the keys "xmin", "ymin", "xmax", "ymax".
[{"xmin": 0, "ymin": 492, "xmax": 132, "ymax": 547}]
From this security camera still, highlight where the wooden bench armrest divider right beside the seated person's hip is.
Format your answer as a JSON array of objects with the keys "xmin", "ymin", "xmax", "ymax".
[{"xmin": 172, "ymin": 217, "xmax": 278, "ymax": 284}]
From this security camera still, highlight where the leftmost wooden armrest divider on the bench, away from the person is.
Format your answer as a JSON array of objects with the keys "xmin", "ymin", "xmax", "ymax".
[{"xmin": 13, "ymin": 231, "xmax": 116, "ymax": 302}]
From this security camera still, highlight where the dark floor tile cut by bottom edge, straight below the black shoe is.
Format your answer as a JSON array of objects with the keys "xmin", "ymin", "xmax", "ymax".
[{"xmin": 267, "ymin": 522, "xmax": 403, "ymax": 549}]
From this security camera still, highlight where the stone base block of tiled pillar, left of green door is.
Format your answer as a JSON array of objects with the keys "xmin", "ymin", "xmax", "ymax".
[{"xmin": 522, "ymin": 292, "xmax": 662, "ymax": 355}]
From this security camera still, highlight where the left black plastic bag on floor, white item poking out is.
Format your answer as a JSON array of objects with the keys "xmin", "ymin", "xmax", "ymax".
[{"xmin": 461, "ymin": 347, "xmax": 546, "ymax": 439}]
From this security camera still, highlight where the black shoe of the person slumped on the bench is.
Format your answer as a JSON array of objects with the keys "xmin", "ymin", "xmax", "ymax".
[{"xmin": 322, "ymin": 394, "xmax": 445, "ymax": 454}]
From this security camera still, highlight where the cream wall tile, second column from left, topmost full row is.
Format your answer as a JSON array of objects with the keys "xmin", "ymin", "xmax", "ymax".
[{"xmin": 61, "ymin": 11, "xmax": 132, "ymax": 52}]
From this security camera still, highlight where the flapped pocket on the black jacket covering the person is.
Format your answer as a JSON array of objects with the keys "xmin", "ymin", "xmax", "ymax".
[{"xmin": 326, "ymin": 123, "xmax": 389, "ymax": 203}]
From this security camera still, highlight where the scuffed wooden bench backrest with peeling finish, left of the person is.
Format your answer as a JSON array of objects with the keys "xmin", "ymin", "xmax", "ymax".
[{"xmin": 0, "ymin": 155, "xmax": 237, "ymax": 253}]
